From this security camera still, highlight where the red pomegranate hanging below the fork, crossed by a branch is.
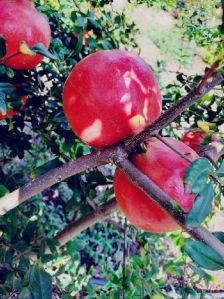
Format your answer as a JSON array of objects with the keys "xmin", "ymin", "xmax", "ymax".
[{"xmin": 114, "ymin": 137, "xmax": 198, "ymax": 233}]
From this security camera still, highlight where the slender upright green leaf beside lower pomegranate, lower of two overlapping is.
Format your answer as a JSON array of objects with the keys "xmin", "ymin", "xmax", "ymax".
[{"xmin": 186, "ymin": 182, "xmax": 214, "ymax": 227}]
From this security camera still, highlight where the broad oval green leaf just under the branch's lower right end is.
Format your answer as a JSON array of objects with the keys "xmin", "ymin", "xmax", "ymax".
[{"xmin": 184, "ymin": 239, "xmax": 224, "ymax": 271}]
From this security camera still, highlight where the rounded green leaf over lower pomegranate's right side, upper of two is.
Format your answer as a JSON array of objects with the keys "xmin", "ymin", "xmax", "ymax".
[{"xmin": 184, "ymin": 158, "xmax": 212, "ymax": 194}]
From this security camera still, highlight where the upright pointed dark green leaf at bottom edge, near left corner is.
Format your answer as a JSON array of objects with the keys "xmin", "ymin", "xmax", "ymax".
[{"xmin": 29, "ymin": 262, "xmax": 52, "ymax": 299}]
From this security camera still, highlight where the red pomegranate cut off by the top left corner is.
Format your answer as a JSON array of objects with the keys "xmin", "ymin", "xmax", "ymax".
[{"xmin": 0, "ymin": 0, "xmax": 51, "ymax": 70}]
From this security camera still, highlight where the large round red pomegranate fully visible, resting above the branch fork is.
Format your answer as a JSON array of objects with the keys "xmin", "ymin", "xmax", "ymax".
[{"xmin": 63, "ymin": 50, "xmax": 161, "ymax": 147}]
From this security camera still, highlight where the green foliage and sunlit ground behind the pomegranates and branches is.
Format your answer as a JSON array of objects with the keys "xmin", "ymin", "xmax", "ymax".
[{"xmin": 0, "ymin": 0, "xmax": 224, "ymax": 299}]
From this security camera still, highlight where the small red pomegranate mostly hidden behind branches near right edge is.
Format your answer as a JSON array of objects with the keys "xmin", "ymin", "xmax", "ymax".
[{"xmin": 181, "ymin": 130, "xmax": 218, "ymax": 151}]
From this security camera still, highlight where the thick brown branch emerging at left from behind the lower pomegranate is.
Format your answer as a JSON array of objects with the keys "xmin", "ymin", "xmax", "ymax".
[{"xmin": 55, "ymin": 198, "xmax": 118, "ymax": 246}]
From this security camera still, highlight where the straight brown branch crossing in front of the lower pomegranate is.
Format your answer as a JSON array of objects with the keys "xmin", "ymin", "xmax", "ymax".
[{"xmin": 114, "ymin": 157, "xmax": 224, "ymax": 259}]
